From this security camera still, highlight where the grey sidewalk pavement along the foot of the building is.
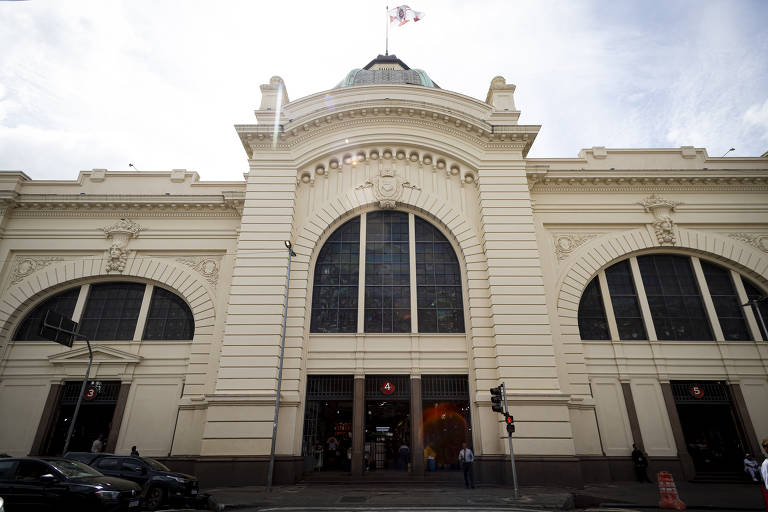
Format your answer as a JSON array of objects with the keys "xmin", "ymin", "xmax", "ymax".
[{"xmin": 205, "ymin": 482, "xmax": 765, "ymax": 512}]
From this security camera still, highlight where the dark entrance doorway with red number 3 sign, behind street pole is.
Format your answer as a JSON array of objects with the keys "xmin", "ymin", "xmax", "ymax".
[{"xmin": 42, "ymin": 381, "xmax": 120, "ymax": 455}]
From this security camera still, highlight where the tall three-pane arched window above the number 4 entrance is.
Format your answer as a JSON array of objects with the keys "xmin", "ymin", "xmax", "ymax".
[{"xmin": 310, "ymin": 210, "xmax": 464, "ymax": 333}]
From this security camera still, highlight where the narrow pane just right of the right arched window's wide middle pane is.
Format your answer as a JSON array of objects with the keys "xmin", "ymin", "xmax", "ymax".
[{"xmin": 700, "ymin": 260, "xmax": 751, "ymax": 341}]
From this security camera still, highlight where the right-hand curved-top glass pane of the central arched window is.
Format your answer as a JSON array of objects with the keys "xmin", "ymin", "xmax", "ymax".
[{"xmin": 415, "ymin": 217, "xmax": 464, "ymax": 332}]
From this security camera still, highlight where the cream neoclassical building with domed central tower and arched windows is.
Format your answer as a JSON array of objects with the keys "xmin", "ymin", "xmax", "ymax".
[{"xmin": 0, "ymin": 55, "xmax": 768, "ymax": 485}]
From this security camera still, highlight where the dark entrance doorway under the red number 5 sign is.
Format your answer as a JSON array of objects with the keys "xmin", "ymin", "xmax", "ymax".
[{"xmin": 671, "ymin": 381, "xmax": 747, "ymax": 473}]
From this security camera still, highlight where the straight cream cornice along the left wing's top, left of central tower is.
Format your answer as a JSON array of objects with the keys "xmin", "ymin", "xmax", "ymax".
[{"xmin": 4, "ymin": 191, "xmax": 245, "ymax": 217}]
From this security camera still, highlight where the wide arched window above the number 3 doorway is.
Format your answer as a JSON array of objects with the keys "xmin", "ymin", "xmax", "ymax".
[{"xmin": 13, "ymin": 281, "xmax": 195, "ymax": 341}]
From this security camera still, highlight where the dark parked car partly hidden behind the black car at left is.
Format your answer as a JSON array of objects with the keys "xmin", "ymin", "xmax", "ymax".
[{"xmin": 65, "ymin": 452, "xmax": 199, "ymax": 510}]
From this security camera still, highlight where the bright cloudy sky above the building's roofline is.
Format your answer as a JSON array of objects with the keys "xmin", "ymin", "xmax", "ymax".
[{"xmin": 0, "ymin": 0, "xmax": 768, "ymax": 180}]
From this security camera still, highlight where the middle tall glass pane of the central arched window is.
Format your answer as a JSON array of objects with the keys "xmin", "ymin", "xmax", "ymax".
[{"xmin": 365, "ymin": 211, "xmax": 411, "ymax": 332}]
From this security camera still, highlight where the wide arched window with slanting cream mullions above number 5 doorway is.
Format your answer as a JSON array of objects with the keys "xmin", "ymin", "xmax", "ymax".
[{"xmin": 578, "ymin": 254, "xmax": 768, "ymax": 341}]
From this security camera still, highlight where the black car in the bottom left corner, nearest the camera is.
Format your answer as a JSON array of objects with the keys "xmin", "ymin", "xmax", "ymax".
[{"xmin": 0, "ymin": 457, "xmax": 141, "ymax": 512}]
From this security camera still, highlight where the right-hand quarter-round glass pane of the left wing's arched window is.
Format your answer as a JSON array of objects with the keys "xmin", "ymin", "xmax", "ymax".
[{"xmin": 142, "ymin": 286, "xmax": 195, "ymax": 340}]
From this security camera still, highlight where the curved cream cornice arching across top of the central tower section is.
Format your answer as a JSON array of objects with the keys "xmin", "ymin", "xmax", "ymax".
[{"xmin": 235, "ymin": 100, "xmax": 540, "ymax": 158}]
